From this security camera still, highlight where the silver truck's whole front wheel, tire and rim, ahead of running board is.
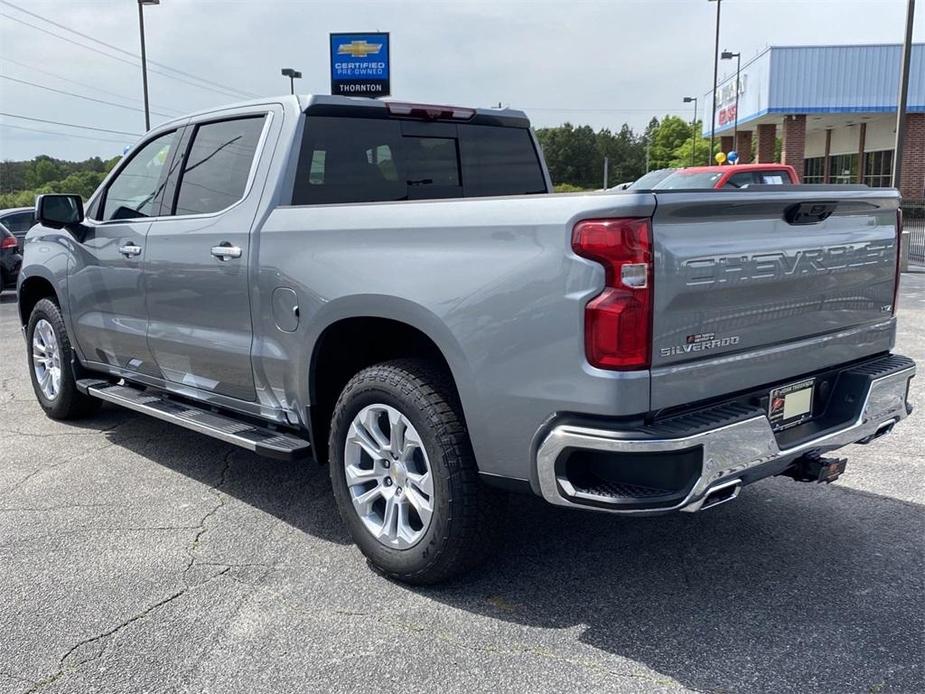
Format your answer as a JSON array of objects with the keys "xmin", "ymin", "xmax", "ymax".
[{"xmin": 26, "ymin": 299, "xmax": 100, "ymax": 419}]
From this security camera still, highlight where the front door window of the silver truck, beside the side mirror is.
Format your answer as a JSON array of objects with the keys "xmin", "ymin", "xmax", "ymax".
[{"xmin": 102, "ymin": 131, "xmax": 177, "ymax": 221}]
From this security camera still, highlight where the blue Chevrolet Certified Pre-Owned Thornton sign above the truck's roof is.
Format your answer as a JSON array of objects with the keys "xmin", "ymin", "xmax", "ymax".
[{"xmin": 331, "ymin": 33, "xmax": 390, "ymax": 97}]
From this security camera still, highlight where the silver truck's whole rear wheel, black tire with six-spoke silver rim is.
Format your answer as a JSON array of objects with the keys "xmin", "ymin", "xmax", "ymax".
[{"xmin": 329, "ymin": 360, "xmax": 503, "ymax": 584}]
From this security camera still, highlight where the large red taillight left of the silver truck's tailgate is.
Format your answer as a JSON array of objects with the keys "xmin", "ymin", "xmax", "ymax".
[{"xmin": 572, "ymin": 218, "xmax": 652, "ymax": 369}]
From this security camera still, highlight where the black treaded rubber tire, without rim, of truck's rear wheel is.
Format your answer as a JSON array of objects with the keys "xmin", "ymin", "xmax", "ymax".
[{"xmin": 328, "ymin": 360, "xmax": 504, "ymax": 585}]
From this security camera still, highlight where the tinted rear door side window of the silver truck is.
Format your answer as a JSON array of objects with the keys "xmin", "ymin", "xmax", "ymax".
[{"xmin": 174, "ymin": 116, "xmax": 265, "ymax": 215}]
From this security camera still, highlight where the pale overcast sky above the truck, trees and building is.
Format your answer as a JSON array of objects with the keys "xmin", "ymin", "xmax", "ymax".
[{"xmin": 0, "ymin": 0, "xmax": 925, "ymax": 159}]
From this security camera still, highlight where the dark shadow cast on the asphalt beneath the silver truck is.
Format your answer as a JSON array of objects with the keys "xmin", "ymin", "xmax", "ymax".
[{"xmin": 85, "ymin": 410, "xmax": 925, "ymax": 693}]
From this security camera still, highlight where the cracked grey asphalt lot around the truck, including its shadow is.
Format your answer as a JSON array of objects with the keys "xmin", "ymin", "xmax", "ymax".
[{"xmin": 0, "ymin": 273, "xmax": 925, "ymax": 693}]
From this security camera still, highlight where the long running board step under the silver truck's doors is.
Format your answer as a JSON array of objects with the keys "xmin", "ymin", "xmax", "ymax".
[{"xmin": 77, "ymin": 379, "xmax": 311, "ymax": 460}]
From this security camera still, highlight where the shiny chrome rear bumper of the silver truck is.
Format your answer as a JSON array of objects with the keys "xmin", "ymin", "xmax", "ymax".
[{"xmin": 536, "ymin": 356, "xmax": 915, "ymax": 514}]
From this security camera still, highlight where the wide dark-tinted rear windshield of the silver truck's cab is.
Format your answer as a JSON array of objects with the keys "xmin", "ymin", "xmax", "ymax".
[{"xmin": 293, "ymin": 116, "xmax": 546, "ymax": 205}]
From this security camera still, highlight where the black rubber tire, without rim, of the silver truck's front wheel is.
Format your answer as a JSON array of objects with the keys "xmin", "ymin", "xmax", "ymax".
[{"xmin": 26, "ymin": 299, "xmax": 101, "ymax": 419}]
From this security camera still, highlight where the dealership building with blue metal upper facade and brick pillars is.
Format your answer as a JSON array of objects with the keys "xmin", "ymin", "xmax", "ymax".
[{"xmin": 704, "ymin": 44, "xmax": 925, "ymax": 199}]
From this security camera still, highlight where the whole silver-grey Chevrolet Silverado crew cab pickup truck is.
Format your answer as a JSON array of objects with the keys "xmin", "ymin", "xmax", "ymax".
[{"xmin": 19, "ymin": 96, "xmax": 915, "ymax": 583}]
